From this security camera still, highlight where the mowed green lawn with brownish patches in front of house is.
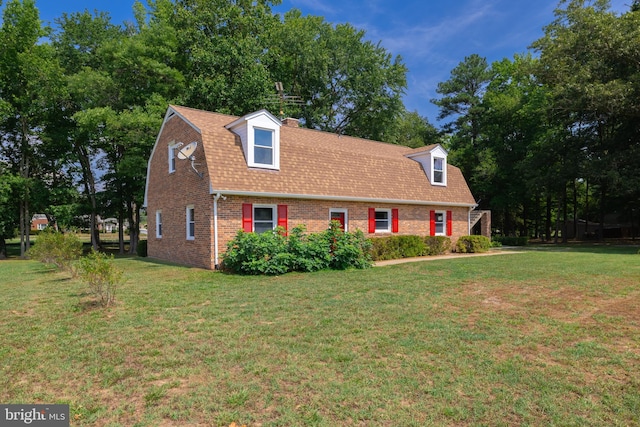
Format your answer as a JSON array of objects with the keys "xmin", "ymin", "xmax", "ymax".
[{"xmin": 0, "ymin": 247, "xmax": 640, "ymax": 426}]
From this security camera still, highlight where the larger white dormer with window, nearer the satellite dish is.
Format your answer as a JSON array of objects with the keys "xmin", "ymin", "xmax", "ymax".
[{"xmin": 225, "ymin": 110, "xmax": 282, "ymax": 170}]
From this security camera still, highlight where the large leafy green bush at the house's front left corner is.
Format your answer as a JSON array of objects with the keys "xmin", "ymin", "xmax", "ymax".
[{"xmin": 222, "ymin": 221, "xmax": 371, "ymax": 274}]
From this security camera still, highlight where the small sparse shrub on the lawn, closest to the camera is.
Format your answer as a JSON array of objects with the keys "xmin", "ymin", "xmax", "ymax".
[{"xmin": 78, "ymin": 249, "xmax": 122, "ymax": 307}]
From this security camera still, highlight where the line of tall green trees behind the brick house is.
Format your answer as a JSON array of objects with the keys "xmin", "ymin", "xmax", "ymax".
[{"xmin": 0, "ymin": 0, "xmax": 640, "ymax": 260}]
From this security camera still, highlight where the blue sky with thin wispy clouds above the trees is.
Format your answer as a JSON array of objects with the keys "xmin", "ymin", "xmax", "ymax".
[{"xmin": 30, "ymin": 0, "xmax": 631, "ymax": 124}]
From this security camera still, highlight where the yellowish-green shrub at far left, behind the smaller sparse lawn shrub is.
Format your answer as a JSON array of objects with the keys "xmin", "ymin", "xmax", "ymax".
[{"xmin": 28, "ymin": 228, "xmax": 82, "ymax": 276}]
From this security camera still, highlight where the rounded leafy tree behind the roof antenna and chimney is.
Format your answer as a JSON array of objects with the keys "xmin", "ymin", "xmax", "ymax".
[{"xmin": 269, "ymin": 9, "xmax": 407, "ymax": 140}]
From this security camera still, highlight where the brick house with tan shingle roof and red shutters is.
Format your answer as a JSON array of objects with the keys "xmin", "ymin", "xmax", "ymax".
[{"xmin": 145, "ymin": 106, "xmax": 484, "ymax": 269}]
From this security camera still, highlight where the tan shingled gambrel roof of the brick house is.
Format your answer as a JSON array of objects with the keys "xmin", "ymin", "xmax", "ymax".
[{"xmin": 146, "ymin": 105, "xmax": 475, "ymax": 207}]
